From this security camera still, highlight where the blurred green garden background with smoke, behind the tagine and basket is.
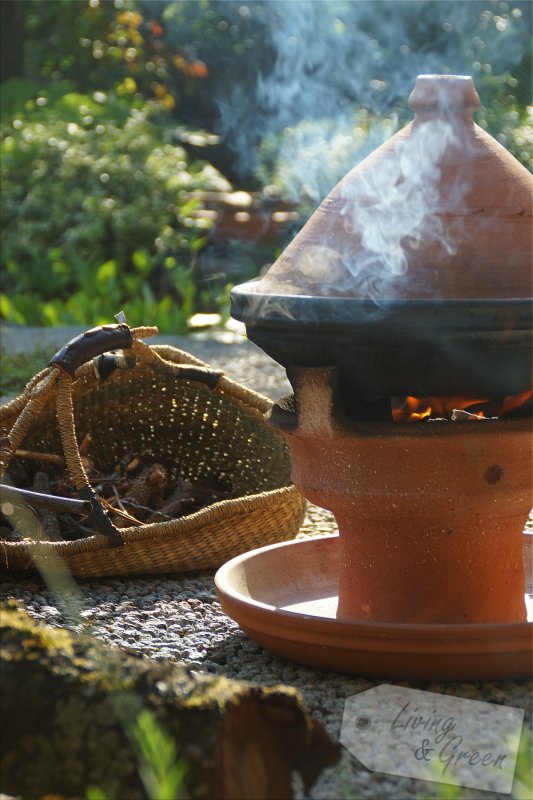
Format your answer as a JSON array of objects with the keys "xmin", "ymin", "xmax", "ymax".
[{"xmin": 0, "ymin": 0, "xmax": 533, "ymax": 332}]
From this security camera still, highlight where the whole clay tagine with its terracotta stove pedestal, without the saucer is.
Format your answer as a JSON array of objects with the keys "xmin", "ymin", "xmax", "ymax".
[{"xmin": 232, "ymin": 76, "xmax": 532, "ymax": 623}]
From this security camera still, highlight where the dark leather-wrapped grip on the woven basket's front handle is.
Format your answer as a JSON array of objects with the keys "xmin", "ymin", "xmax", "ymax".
[{"xmin": 48, "ymin": 322, "xmax": 133, "ymax": 378}]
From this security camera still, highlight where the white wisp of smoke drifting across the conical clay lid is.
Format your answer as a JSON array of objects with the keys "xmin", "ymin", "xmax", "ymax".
[{"xmin": 334, "ymin": 112, "xmax": 468, "ymax": 302}]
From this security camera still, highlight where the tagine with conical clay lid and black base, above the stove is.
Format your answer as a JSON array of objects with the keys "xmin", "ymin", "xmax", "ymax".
[{"xmin": 232, "ymin": 75, "xmax": 533, "ymax": 400}]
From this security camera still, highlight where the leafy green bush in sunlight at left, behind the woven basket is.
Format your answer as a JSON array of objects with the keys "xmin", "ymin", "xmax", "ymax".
[{"xmin": 0, "ymin": 92, "xmax": 229, "ymax": 332}]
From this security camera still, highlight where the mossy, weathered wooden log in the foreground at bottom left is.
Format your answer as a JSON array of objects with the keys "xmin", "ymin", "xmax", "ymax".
[{"xmin": 0, "ymin": 602, "xmax": 339, "ymax": 800}]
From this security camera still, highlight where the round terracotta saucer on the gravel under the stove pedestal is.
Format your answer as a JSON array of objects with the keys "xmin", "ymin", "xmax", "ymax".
[{"xmin": 215, "ymin": 534, "xmax": 533, "ymax": 681}]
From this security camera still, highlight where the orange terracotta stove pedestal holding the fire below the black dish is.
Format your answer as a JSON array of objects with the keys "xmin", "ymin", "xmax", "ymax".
[{"xmin": 272, "ymin": 368, "xmax": 533, "ymax": 623}]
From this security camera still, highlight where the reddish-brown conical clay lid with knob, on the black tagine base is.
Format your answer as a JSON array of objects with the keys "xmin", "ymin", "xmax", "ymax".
[{"xmin": 256, "ymin": 75, "xmax": 533, "ymax": 302}]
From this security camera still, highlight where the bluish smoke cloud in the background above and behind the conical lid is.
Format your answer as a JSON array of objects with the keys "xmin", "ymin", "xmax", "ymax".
[{"xmin": 212, "ymin": 0, "xmax": 528, "ymax": 192}]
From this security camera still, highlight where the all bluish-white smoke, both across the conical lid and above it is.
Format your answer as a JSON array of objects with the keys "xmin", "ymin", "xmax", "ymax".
[{"xmin": 160, "ymin": 0, "xmax": 530, "ymax": 300}]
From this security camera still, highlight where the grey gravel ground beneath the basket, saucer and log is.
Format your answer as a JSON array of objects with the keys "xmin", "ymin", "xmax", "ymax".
[{"xmin": 0, "ymin": 329, "xmax": 533, "ymax": 800}]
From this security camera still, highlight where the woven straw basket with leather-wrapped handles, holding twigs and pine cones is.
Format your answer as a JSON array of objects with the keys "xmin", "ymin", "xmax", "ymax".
[{"xmin": 0, "ymin": 324, "xmax": 305, "ymax": 577}]
